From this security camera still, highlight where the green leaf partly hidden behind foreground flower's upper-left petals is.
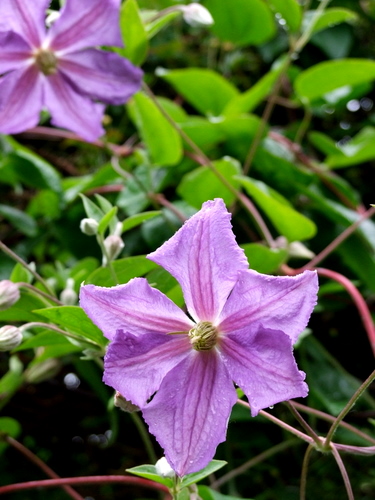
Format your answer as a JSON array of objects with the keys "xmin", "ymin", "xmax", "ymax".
[{"xmin": 86, "ymin": 256, "xmax": 156, "ymax": 286}]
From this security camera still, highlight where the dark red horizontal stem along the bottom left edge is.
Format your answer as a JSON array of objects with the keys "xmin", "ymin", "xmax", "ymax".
[{"xmin": 0, "ymin": 476, "xmax": 169, "ymax": 495}]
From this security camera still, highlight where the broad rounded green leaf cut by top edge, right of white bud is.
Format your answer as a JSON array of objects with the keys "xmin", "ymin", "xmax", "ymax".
[{"xmin": 202, "ymin": 0, "xmax": 276, "ymax": 46}]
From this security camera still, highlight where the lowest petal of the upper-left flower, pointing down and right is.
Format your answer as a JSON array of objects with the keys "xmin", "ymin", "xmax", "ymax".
[{"xmin": 44, "ymin": 72, "xmax": 104, "ymax": 141}]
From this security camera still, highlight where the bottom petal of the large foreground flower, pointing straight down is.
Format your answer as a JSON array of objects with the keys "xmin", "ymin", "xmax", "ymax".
[{"xmin": 143, "ymin": 350, "xmax": 237, "ymax": 476}]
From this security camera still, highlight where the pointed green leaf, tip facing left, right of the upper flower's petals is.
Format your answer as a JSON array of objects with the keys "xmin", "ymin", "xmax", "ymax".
[{"xmin": 157, "ymin": 68, "xmax": 238, "ymax": 116}]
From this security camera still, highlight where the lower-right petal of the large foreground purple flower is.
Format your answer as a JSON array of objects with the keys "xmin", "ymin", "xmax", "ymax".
[{"xmin": 220, "ymin": 328, "xmax": 308, "ymax": 417}]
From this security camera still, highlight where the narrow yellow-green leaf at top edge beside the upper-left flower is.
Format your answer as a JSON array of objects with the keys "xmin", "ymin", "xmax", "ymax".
[{"xmin": 116, "ymin": 0, "xmax": 148, "ymax": 65}]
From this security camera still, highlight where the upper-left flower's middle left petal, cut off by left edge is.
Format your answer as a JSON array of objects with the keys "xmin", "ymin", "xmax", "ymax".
[{"xmin": 0, "ymin": 31, "xmax": 31, "ymax": 74}]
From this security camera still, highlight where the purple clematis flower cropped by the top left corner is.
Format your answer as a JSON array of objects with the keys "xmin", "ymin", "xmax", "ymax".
[{"xmin": 0, "ymin": 0, "xmax": 142, "ymax": 141}]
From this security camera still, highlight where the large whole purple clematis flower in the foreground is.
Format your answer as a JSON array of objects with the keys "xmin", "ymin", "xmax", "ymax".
[{"xmin": 81, "ymin": 199, "xmax": 318, "ymax": 476}]
